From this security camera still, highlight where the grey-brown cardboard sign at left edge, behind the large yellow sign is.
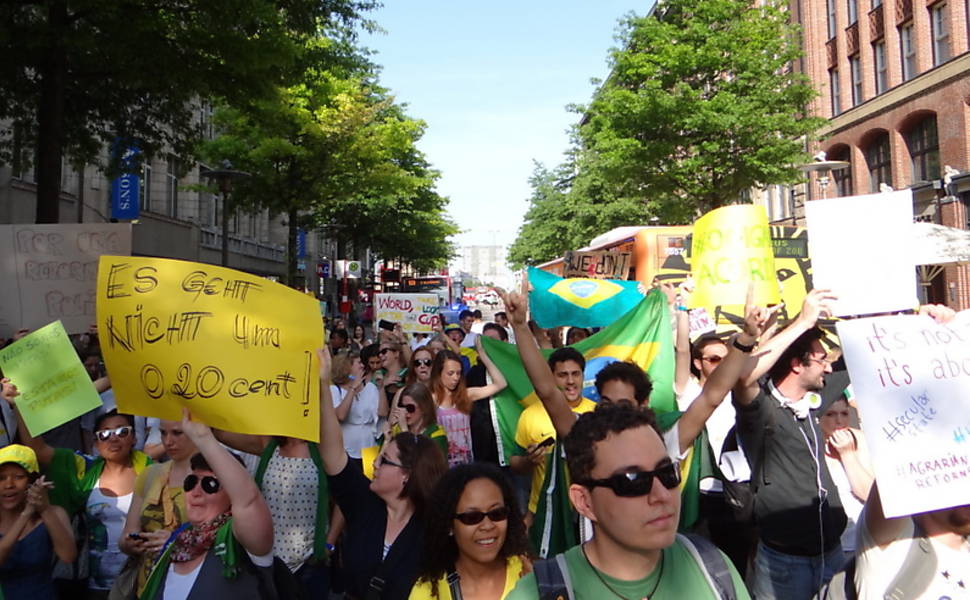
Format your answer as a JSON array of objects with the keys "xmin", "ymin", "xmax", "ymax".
[{"xmin": 0, "ymin": 223, "xmax": 131, "ymax": 336}]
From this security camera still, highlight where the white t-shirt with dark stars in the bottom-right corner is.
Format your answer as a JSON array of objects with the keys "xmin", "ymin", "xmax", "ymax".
[{"xmin": 855, "ymin": 509, "xmax": 970, "ymax": 600}]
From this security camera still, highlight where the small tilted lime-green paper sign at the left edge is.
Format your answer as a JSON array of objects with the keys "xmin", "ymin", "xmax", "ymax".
[{"xmin": 0, "ymin": 321, "xmax": 101, "ymax": 437}]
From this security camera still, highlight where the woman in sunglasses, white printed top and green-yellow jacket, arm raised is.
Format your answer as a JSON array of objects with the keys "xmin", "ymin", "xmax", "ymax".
[{"xmin": 10, "ymin": 392, "xmax": 152, "ymax": 600}]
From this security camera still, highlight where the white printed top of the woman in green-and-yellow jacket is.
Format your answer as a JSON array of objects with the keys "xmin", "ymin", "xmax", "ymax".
[{"xmin": 86, "ymin": 486, "xmax": 132, "ymax": 590}]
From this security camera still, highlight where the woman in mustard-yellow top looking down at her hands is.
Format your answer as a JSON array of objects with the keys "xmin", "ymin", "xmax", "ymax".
[{"xmin": 115, "ymin": 419, "xmax": 198, "ymax": 598}]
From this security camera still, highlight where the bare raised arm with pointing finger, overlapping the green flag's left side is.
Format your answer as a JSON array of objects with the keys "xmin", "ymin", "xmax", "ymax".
[{"xmin": 502, "ymin": 279, "xmax": 576, "ymax": 438}]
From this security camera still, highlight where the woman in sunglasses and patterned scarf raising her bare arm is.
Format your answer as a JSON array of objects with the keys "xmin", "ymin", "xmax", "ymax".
[{"xmin": 140, "ymin": 409, "xmax": 278, "ymax": 600}]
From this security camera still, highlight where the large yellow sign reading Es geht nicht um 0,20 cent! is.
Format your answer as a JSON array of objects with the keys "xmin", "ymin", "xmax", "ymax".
[{"xmin": 97, "ymin": 256, "xmax": 323, "ymax": 441}]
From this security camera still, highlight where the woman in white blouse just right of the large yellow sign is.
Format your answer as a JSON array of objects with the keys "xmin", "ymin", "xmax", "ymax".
[{"xmin": 330, "ymin": 352, "xmax": 387, "ymax": 460}]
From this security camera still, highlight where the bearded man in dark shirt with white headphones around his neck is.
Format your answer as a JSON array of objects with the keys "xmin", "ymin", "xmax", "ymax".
[{"xmin": 734, "ymin": 290, "xmax": 846, "ymax": 600}]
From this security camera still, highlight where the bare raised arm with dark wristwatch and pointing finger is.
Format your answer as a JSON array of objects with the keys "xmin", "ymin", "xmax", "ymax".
[{"xmin": 678, "ymin": 288, "xmax": 771, "ymax": 453}]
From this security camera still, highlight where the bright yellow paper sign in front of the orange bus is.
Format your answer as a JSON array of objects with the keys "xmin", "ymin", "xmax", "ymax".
[{"xmin": 690, "ymin": 204, "xmax": 779, "ymax": 308}]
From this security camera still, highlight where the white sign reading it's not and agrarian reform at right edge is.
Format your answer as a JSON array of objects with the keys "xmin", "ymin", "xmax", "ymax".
[{"xmin": 836, "ymin": 311, "xmax": 970, "ymax": 517}]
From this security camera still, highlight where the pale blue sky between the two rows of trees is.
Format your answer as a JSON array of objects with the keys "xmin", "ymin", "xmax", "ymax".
[{"xmin": 361, "ymin": 0, "xmax": 652, "ymax": 245}]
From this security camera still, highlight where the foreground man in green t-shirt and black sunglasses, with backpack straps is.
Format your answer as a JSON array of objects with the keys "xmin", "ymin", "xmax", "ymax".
[{"xmin": 507, "ymin": 404, "xmax": 748, "ymax": 600}]
